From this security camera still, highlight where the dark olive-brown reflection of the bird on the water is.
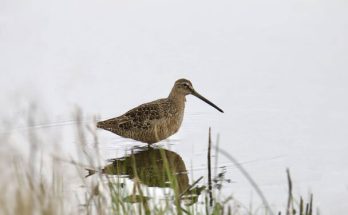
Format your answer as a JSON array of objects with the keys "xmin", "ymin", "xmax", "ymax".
[{"xmin": 86, "ymin": 147, "xmax": 205, "ymax": 205}]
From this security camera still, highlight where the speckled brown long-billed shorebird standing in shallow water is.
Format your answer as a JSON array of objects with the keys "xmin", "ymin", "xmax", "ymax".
[{"xmin": 97, "ymin": 79, "xmax": 222, "ymax": 144}]
